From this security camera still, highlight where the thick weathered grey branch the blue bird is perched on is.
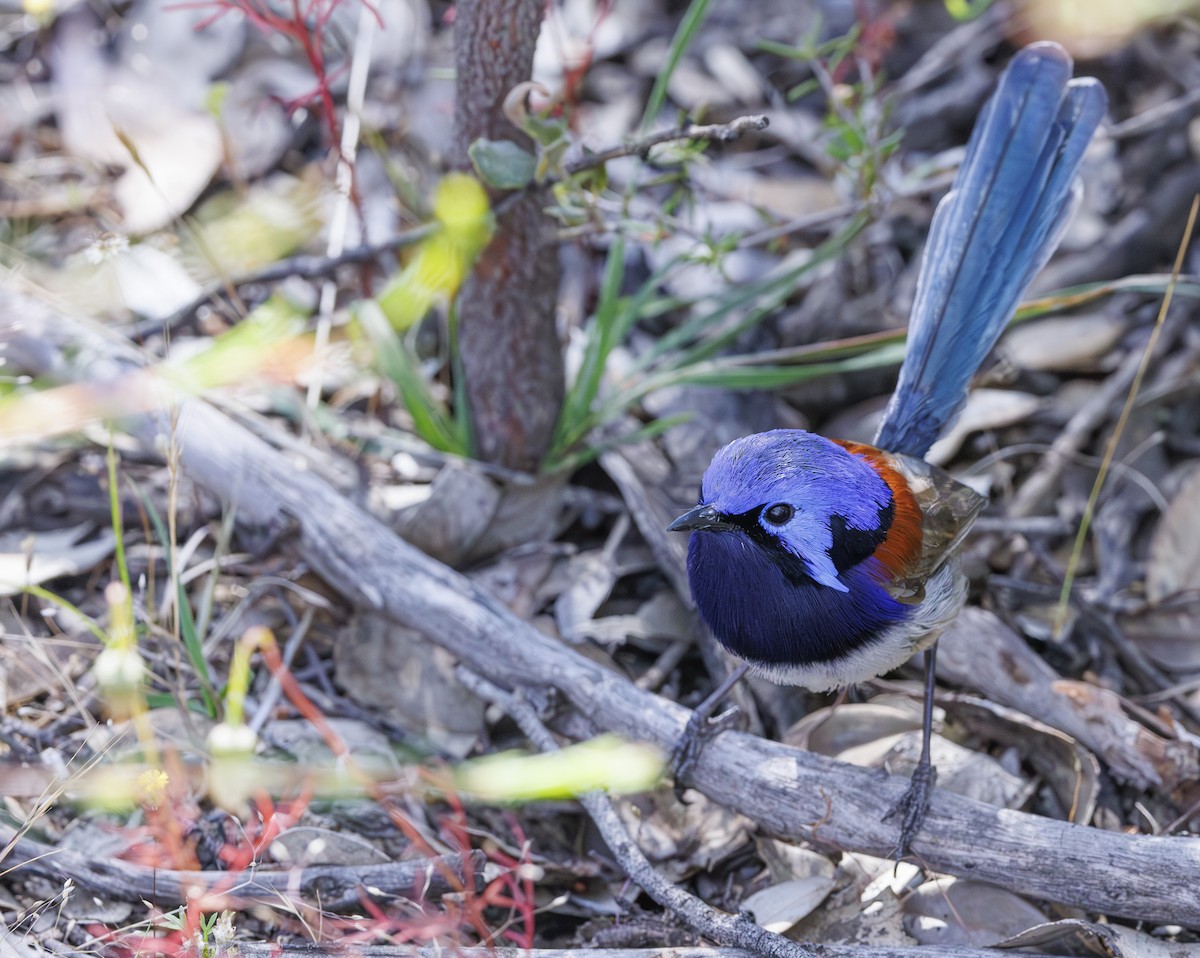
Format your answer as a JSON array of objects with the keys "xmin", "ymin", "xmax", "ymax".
[{"xmin": 138, "ymin": 393, "xmax": 1200, "ymax": 927}]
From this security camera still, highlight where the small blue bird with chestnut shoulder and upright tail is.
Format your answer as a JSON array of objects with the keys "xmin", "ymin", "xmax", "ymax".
[{"xmin": 668, "ymin": 43, "xmax": 1106, "ymax": 856}]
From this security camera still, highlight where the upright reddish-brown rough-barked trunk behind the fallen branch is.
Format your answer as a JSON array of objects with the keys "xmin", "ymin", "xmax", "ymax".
[{"xmin": 454, "ymin": 0, "xmax": 564, "ymax": 471}]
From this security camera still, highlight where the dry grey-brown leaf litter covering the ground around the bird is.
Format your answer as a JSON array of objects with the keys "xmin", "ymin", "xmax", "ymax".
[{"xmin": 0, "ymin": 0, "xmax": 1200, "ymax": 956}]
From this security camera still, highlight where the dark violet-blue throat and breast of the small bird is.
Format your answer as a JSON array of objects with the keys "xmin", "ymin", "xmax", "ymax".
[{"xmin": 688, "ymin": 531, "xmax": 912, "ymax": 665}]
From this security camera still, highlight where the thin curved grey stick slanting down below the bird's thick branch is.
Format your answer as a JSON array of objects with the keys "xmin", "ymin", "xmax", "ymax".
[{"xmin": 458, "ymin": 669, "xmax": 815, "ymax": 958}]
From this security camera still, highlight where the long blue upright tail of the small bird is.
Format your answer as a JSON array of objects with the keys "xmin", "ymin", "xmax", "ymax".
[{"xmin": 875, "ymin": 43, "xmax": 1106, "ymax": 456}]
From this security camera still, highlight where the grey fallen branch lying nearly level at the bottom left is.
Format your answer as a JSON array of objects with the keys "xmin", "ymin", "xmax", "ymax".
[{"xmin": 0, "ymin": 825, "xmax": 486, "ymax": 911}]
